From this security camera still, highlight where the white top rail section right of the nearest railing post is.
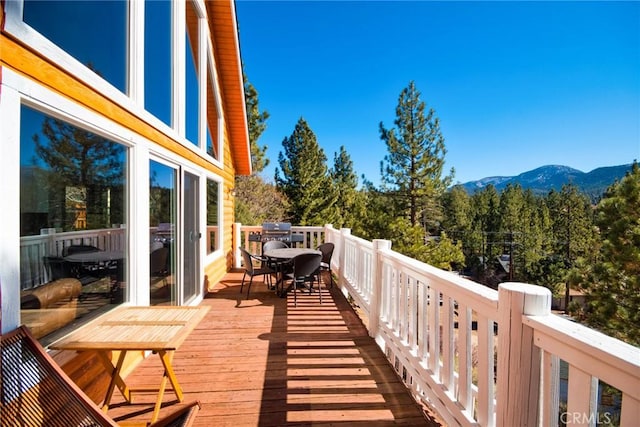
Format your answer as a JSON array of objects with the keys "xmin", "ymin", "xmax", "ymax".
[{"xmin": 522, "ymin": 315, "xmax": 640, "ymax": 400}]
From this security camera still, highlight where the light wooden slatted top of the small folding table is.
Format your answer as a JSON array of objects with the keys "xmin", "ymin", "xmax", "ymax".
[{"xmin": 50, "ymin": 306, "xmax": 209, "ymax": 351}]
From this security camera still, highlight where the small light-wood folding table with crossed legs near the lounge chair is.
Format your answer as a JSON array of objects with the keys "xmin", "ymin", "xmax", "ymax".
[{"xmin": 49, "ymin": 306, "xmax": 209, "ymax": 422}]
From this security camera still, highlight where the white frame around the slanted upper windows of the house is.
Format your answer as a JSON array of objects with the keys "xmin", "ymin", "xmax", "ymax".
[{"xmin": 4, "ymin": 0, "xmax": 225, "ymax": 170}]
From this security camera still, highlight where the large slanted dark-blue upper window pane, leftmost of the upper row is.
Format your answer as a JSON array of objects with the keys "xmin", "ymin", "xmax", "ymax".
[{"xmin": 23, "ymin": 0, "xmax": 128, "ymax": 93}]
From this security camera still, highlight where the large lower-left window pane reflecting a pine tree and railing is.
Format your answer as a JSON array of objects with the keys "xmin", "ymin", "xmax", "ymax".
[{"xmin": 20, "ymin": 106, "xmax": 127, "ymax": 342}]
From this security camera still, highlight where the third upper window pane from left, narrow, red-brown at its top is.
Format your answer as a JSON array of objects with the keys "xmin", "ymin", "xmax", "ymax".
[{"xmin": 185, "ymin": 1, "xmax": 200, "ymax": 146}]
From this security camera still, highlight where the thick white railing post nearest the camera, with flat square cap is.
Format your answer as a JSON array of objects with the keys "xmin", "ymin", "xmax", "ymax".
[{"xmin": 498, "ymin": 282, "xmax": 551, "ymax": 427}]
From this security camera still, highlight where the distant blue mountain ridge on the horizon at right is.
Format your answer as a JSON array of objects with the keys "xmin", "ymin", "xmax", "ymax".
[{"xmin": 459, "ymin": 164, "xmax": 631, "ymax": 201}]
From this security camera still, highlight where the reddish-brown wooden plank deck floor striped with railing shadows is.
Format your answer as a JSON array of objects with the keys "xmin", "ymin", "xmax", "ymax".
[{"xmin": 109, "ymin": 273, "xmax": 440, "ymax": 427}]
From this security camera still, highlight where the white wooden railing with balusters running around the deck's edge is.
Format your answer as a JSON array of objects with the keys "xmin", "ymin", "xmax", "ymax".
[{"xmin": 236, "ymin": 224, "xmax": 640, "ymax": 427}]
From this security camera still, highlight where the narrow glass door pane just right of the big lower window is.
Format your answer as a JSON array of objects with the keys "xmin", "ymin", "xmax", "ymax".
[{"xmin": 149, "ymin": 160, "xmax": 178, "ymax": 305}]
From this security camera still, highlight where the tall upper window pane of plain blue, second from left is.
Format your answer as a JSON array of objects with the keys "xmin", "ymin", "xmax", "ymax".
[{"xmin": 144, "ymin": 0, "xmax": 171, "ymax": 126}]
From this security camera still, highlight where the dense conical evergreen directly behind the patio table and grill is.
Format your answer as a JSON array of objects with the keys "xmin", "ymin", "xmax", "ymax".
[{"xmin": 275, "ymin": 118, "xmax": 337, "ymax": 225}]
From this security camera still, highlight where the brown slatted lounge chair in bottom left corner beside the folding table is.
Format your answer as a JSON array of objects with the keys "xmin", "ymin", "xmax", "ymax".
[{"xmin": 0, "ymin": 326, "xmax": 200, "ymax": 427}]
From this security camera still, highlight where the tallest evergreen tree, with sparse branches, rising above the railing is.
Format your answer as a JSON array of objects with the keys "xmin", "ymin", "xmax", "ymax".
[{"xmin": 380, "ymin": 81, "xmax": 453, "ymax": 229}]
